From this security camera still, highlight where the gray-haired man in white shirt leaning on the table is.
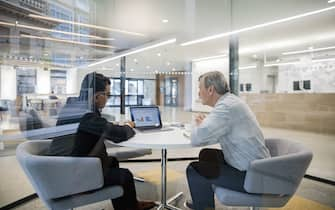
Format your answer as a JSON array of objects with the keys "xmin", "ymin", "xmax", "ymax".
[{"xmin": 186, "ymin": 71, "xmax": 270, "ymax": 210}]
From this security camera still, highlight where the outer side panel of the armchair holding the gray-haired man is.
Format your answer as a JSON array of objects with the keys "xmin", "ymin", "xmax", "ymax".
[{"xmin": 244, "ymin": 151, "xmax": 312, "ymax": 195}]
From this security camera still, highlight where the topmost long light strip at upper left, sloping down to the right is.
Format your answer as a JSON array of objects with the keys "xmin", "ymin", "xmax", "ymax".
[{"xmin": 28, "ymin": 14, "xmax": 145, "ymax": 36}]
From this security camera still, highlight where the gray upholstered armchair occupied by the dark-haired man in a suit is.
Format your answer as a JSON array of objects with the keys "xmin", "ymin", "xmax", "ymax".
[{"xmin": 16, "ymin": 140, "xmax": 123, "ymax": 210}]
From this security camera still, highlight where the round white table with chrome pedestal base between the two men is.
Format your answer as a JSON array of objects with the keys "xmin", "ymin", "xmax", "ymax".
[{"xmin": 110, "ymin": 128, "xmax": 192, "ymax": 210}]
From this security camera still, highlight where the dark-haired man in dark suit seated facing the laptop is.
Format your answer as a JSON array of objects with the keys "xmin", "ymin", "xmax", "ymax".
[{"xmin": 49, "ymin": 72, "xmax": 155, "ymax": 210}]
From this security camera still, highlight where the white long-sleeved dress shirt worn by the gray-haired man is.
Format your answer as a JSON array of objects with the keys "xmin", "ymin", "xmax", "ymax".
[{"xmin": 191, "ymin": 93, "xmax": 270, "ymax": 171}]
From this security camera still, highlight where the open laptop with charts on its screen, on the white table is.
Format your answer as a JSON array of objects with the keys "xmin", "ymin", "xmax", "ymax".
[{"xmin": 129, "ymin": 106, "xmax": 173, "ymax": 132}]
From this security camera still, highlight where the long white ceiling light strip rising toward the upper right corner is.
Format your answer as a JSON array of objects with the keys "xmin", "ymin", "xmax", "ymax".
[{"xmin": 180, "ymin": 6, "xmax": 335, "ymax": 46}]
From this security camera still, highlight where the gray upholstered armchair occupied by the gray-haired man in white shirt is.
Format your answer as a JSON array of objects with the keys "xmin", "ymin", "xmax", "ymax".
[{"xmin": 213, "ymin": 139, "xmax": 313, "ymax": 209}]
